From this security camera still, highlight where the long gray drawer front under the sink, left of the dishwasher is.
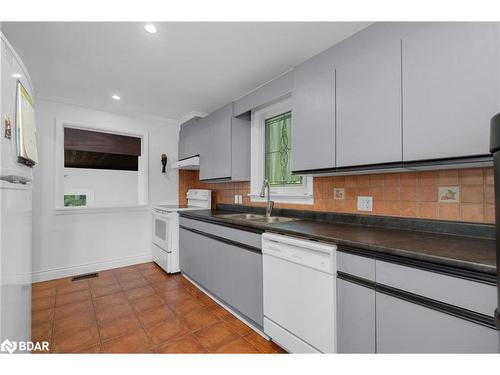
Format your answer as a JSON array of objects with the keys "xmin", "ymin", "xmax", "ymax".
[{"xmin": 179, "ymin": 217, "xmax": 261, "ymax": 249}]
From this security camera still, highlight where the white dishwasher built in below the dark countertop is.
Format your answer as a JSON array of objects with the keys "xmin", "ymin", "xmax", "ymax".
[{"xmin": 262, "ymin": 233, "xmax": 337, "ymax": 353}]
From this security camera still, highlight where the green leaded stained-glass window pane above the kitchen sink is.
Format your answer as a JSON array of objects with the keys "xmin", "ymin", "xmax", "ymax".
[{"xmin": 265, "ymin": 112, "xmax": 302, "ymax": 186}]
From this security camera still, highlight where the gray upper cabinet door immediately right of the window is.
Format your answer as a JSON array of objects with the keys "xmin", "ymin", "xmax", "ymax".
[{"xmin": 291, "ymin": 58, "xmax": 335, "ymax": 171}]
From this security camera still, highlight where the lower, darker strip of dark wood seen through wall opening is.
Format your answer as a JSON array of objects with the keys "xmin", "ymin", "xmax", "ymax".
[{"xmin": 64, "ymin": 150, "xmax": 139, "ymax": 171}]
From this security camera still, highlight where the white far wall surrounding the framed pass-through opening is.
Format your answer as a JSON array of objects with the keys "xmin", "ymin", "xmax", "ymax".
[{"xmin": 33, "ymin": 98, "xmax": 179, "ymax": 281}]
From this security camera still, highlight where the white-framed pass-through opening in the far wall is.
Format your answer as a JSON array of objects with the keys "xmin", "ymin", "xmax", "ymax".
[{"xmin": 55, "ymin": 120, "xmax": 148, "ymax": 213}]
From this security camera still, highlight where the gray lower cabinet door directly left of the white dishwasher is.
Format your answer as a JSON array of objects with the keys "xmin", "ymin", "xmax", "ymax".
[{"xmin": 231, "ymin": 247, "xmax": 264, "ymax": 326}]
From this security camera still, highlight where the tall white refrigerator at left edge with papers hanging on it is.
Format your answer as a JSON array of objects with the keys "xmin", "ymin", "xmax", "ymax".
[{"xmin": 0, "ymin": 33, "xmax": 37, "ymax": 352}]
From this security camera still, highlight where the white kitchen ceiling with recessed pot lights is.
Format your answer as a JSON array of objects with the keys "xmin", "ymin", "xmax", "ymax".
[{"xmin": 2, "ymin": 22, "xmax": 369, "ymax": 119}]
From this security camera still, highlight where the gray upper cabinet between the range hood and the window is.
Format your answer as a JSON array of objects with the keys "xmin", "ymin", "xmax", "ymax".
[{"xmin": 196, "ymin": 103, "xmax": 250, "ymax": 181}]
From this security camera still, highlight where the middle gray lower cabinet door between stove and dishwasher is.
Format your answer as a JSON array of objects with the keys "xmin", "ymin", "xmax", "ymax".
[{"xmin": 205, "ymin": 238, "xmax": 235, "ymax": 305}]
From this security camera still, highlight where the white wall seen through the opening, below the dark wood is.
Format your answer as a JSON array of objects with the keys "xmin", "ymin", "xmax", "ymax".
[{"xmin": 64, "ymin": 168, "xmax": 140, "ymax": 207}]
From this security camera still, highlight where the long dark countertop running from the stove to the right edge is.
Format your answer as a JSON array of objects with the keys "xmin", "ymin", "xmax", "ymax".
[{"xmin": 180, "ymin": 210, "xmax": 496, "ymax": 274}]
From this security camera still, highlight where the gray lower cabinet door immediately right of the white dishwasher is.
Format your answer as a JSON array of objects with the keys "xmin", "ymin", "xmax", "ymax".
[{"xmin": 337, "ymin": 279, "xmax": 375, "ymax": 353}]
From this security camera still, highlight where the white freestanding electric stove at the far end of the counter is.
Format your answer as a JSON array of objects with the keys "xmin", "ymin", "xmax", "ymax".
[{"xmin": 153, "ymin": 189, "xmax": 212, "ymax": 273}]
